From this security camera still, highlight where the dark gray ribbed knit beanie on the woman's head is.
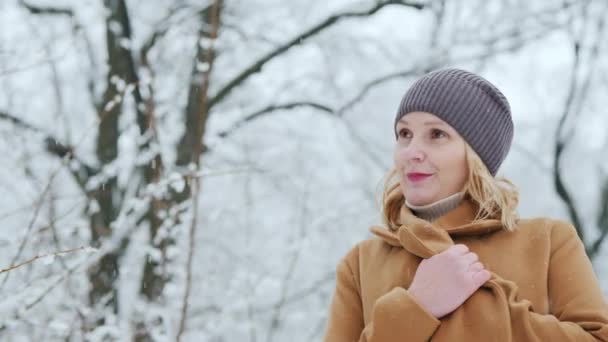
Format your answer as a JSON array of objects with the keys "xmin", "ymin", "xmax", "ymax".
[{"xmin": 395, "ymin": 69, "xmax": 513, "ymax": 176}]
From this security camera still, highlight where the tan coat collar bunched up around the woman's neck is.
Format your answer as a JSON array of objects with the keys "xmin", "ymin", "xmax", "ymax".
[{"xmin": 370, "ymin": 199, "xmax": 502, "ymax": 258}]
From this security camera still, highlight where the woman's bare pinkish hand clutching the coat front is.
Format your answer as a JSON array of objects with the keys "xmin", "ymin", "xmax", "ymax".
[{"xmin": 408, "ymin": 245, "xmax": 491, "ymax": 319}]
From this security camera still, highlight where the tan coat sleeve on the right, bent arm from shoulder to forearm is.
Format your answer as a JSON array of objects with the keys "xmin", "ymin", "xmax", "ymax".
[{"xmin": 442, "ymin": 222, "xmax": 608, "ymax": 342}]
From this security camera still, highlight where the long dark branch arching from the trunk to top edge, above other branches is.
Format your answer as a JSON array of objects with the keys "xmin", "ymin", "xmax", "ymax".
[{"xmin": 209, "ymin": 0, "xmax": 426, "ymax": 108}]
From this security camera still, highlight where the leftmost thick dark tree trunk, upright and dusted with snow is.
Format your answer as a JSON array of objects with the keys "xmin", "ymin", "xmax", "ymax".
[{"xmin": 87, "ymin": 0, "xmax": 130, "ymax": 330}]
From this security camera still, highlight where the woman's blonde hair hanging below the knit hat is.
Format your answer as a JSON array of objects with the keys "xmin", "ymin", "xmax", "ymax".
[{"xmin": 382, "ymin": 144, "xmax": 519, "ymax": 231}]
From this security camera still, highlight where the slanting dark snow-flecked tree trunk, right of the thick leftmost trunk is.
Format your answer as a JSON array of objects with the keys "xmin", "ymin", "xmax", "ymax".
[{"xmin": 134, "ymin": 1, "xmax": 221, "ymax": 342}]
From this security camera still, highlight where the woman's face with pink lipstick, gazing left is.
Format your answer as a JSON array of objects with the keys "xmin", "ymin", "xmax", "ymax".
[{"xmin": 394, "ymin": 112, "xmax": 468, "ymax": 205}]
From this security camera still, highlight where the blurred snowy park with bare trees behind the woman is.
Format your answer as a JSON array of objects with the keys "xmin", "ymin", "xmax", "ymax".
[{"xmin": 0, "ymin": 0, "xmax": 608, "ymax": 342}]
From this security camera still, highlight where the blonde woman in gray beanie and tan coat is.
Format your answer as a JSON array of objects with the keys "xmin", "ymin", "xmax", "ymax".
[{"xmin": 325, "ymin": 69, "xmax": 608, "ymax": 342}]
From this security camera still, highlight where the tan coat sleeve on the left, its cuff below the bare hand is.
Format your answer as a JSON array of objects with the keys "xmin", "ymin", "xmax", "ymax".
[{"xmin": 323, "ymin": 247, "xmax": 440, "ymax": 342}]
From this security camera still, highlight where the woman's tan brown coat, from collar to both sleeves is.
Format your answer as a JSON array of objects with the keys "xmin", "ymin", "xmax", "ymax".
[{"xmin": 324, "ymin": 201, "xmax": 608, "ymax": 342}]
